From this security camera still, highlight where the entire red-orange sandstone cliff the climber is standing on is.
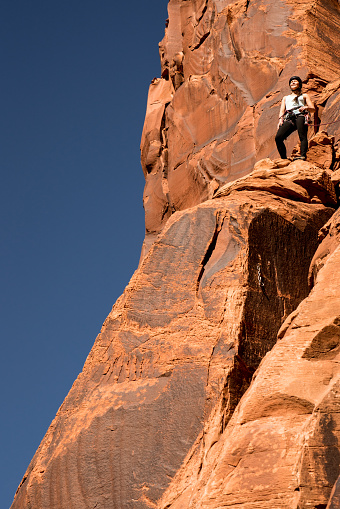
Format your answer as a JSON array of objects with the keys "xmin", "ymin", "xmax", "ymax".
[{"xmin": 12, "ymin": 0, "xmax": 340, "ymax": 509}]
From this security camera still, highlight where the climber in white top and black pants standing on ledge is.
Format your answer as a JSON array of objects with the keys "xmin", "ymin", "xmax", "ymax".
[{"xmin": 275, "ymin": 76, "xmax": 315, "ymax": 160}]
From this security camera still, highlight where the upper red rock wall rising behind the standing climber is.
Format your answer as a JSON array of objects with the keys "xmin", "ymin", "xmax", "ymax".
[{"xmin": 141, "ymin": 0, "xmax": 340, "ymax": 248}]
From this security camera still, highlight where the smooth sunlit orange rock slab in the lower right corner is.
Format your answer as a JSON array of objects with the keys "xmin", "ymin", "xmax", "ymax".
[{"xmin": 160, "ymin": 215, "xmax": 340, "ymax": 509}]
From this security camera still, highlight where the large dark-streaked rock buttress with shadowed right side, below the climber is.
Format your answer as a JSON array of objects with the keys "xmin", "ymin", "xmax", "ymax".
[{"xmin": 13, "ymin": 181, "xmax": 333, "ymax": 508}]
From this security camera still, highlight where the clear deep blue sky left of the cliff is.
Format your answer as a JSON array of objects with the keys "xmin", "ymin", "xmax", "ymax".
[{"xmin": 0, "ymin": 0, "xmax": 167, "ymax": 508}]
